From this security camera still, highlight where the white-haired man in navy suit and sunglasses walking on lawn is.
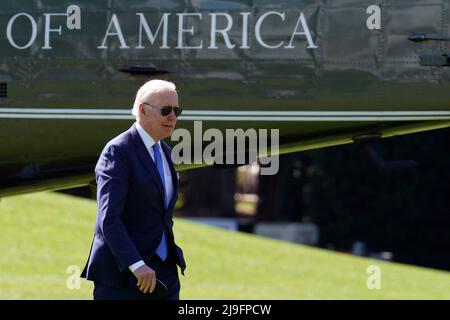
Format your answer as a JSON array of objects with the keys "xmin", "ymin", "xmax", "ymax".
[{"xmin": 81, "ymin": 80, "xmax": 186, "ymax": 300}]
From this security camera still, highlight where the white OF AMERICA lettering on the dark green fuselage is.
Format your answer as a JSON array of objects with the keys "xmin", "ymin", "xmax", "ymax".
[{"xmin": 6, "ymin": 11, "xmax": 317, "ymax": 50}]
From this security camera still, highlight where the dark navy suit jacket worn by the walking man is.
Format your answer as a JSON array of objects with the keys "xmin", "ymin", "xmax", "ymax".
[{"xmin": 81, "ymin": 124, "xmax": 186, "ymax": 288}]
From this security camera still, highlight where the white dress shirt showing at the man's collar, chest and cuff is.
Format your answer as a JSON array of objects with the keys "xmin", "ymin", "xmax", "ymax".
[{"xmin": 129, "ymin": 122, "xmax": 173, "ymax": 272}]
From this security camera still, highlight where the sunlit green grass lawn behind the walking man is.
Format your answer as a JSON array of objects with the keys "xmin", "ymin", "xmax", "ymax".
[{"xmin": 0, "ymin": 193, "xmax": 450, "ymax": 299}]
